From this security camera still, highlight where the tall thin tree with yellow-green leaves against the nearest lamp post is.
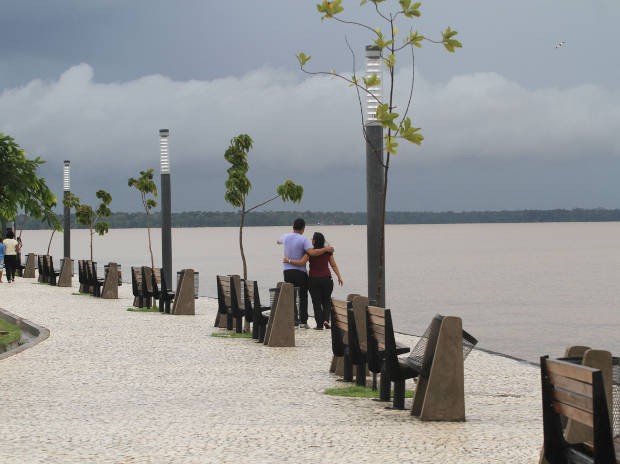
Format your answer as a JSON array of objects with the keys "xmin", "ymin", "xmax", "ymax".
[{"xmin": 297, "ymin": 0, "xmax": 461, "ymax": 301}]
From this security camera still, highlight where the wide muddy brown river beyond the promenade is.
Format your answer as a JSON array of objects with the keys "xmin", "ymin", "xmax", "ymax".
[{"xmin": 22, "ymin": 222, "xmax": 620, "ymax": 361}]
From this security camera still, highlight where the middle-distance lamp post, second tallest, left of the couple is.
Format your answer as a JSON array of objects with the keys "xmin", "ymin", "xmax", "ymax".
[{"xmin": 159, "ymin": 129, "xmax": 173, "ymax": 288}]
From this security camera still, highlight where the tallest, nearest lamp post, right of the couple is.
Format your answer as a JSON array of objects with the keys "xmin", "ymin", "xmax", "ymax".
[{"xmin": 364, "ymin": 45, "xmax": 385, "ymax": 307}]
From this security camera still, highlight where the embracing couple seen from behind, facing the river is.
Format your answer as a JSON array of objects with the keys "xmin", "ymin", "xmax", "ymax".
[{"xmin": 278, "ymin": 218, "xmax": 343, "ymax": 330}]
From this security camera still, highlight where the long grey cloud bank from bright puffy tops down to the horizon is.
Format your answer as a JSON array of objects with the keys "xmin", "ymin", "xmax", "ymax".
[{"xmin": 0, "ymin": 64, "xmax": 620, "ymax": 210}]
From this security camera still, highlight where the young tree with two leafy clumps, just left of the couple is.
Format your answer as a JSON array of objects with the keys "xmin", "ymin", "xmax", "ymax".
[{"xmin": 224, "ymin": 134, "xmax": 304, "ymax": 279}]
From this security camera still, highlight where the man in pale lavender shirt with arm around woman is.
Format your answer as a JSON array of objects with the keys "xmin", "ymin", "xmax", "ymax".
[{"xmin": 277, "ymin": 218, "xmax": 334, "ymax": 329}]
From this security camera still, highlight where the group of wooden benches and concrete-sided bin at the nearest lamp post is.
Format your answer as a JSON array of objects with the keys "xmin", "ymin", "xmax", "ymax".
[{"xmin": 331, "ymin": 295, "xmax": 477, "ymax": 421}]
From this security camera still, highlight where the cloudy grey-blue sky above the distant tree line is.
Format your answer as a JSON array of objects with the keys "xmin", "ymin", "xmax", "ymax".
[{"xmin": 0, "ymin": 0, "xmax": 620, "ymax": 212}]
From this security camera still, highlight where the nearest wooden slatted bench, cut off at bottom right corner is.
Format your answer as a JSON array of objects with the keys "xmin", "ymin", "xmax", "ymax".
[{"xmin": 540, "ymin": 356, "xmax": 620, "ymax": 464}]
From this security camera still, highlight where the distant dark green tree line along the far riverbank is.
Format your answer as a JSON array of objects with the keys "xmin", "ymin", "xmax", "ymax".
[{"xmin": 15, "ymin": 208, "xmax": 620, "ymax": 229}]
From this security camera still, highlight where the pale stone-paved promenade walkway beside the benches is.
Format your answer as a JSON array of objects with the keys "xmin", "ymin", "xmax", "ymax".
[{"xmin": 0, "ymin": 279, "xmax": 542, "ymax": 464}]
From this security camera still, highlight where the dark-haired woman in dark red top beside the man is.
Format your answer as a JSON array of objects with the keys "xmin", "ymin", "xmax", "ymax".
[{"xmin": 283, "ymin": 232, "xmax": 344, "ymax": 330}]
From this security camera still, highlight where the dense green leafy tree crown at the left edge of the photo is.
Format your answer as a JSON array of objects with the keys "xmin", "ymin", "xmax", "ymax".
[{"xmin": 0, "ymin": 132, "xmax": 62, "ymax": 231}]
